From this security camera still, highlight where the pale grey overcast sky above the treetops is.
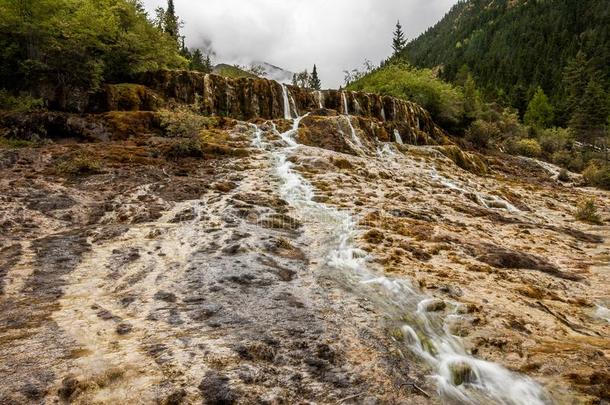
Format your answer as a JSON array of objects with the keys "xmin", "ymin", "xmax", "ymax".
[{"xmin": 144, "ymin": 0, "xmax": 457, "ymax": 87}]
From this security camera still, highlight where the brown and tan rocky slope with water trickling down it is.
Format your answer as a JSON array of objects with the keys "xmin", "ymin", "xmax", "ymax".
[{"xmin": 0, "ymin": 72, "xmax": 610, "ymax": 404}]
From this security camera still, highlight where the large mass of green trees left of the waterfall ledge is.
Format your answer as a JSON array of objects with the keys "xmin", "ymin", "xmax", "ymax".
[{"xmin": 0, "ymin": 0, "xmax": 185, "ymax": 108}]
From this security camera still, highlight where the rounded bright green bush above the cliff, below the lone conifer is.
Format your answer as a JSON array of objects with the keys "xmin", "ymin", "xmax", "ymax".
[{"xmin": 347, "ymin": 63, "xmax": 464, "ymax": 130}]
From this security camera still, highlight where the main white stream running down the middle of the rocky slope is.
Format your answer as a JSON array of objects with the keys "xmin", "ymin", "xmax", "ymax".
[{"xmin": 253, "ymin": 113, "xmax": 552, "ymax": 405}]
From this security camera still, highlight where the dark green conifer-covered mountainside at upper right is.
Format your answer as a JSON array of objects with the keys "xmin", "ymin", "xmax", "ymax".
[{"xmin": 402, "ymin": 0, "xmax": 610, "ymax": 120}]
